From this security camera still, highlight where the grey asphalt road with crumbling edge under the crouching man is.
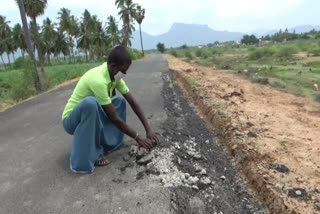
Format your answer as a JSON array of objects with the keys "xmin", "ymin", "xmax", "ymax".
[{"xmin": 0, "ymin": 55, "xmax": 261, "ymax": 214}]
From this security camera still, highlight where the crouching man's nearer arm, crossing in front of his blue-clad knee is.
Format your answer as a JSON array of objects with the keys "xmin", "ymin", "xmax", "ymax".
[{"xmin": 102, "ymin": 104, "xmax": 154, "ymax": 149}]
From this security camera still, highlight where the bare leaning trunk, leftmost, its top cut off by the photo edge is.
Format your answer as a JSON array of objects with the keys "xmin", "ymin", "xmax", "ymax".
[{"xmin": 17, "ymin": 0, "xmax": 41, "ymax": 93}]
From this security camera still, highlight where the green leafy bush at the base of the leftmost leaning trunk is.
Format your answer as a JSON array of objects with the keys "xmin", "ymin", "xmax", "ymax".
[{"xmin": 10, "ymin": 59, "xmax": 35, "ymax": 101}]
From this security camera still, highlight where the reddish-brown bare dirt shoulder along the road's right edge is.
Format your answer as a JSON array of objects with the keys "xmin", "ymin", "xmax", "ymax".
[{"xmin": 168, "ymin": 56, "xmax": 320, "ymax": 213}]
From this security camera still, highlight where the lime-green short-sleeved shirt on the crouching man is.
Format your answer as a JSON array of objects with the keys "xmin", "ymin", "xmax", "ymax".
[{"xmin": 62, "ymin": 63, "xmax": 129, "ymax": 120}]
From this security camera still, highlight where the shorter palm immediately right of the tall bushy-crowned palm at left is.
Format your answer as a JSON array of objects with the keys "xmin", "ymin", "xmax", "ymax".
[{"xmin": 41, "ymin": 18, "xmax": 57, "ymax": 64}]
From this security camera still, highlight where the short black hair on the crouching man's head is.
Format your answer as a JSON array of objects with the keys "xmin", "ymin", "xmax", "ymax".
[{"xmin": 108, "ymin": 46, "xmax": 132, "ymax": 65}]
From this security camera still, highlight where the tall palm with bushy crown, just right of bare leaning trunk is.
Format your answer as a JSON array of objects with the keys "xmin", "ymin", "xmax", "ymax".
[{"xmin": 24, "ymin": 0, "xmax": 48, "ymax": 86}]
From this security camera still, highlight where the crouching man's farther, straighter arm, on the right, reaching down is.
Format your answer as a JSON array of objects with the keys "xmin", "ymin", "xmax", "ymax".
[{"xmin": 123, "ymin": 92, "xmax": 159, "ymax": 143}]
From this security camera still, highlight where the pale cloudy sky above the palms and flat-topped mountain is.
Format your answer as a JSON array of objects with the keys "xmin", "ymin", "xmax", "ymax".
[{"xmin": 0, "ymin": 0, "xmax": 320, "ymax": 35}]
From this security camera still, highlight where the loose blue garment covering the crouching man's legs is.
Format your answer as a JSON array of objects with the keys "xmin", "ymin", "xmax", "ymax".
[{"xmin": 63, "ymin": 96, "xmax": 126, "ymax": 173}]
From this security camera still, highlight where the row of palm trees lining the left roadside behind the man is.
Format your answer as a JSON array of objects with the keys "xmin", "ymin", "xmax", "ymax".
[{"xmin": 0, "ymin": 0, "xmax": 145, "ymax": 92}]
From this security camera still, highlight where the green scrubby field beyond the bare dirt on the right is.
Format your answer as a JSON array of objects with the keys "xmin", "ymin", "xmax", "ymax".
[{"xmin": 167, "ymin": 39, "xmax": 320, "ymax": 101}]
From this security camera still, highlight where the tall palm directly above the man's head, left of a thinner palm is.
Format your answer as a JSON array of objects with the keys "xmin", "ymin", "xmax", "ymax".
[{"xmin": 116, "ymin": 0, "xmax": 137, "ymax": 47}]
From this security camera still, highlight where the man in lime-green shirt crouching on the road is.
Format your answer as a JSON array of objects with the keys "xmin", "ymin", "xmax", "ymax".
[{"xmin": 62, "ymin": 46, "xmax": 159, "ymax": 173}]
